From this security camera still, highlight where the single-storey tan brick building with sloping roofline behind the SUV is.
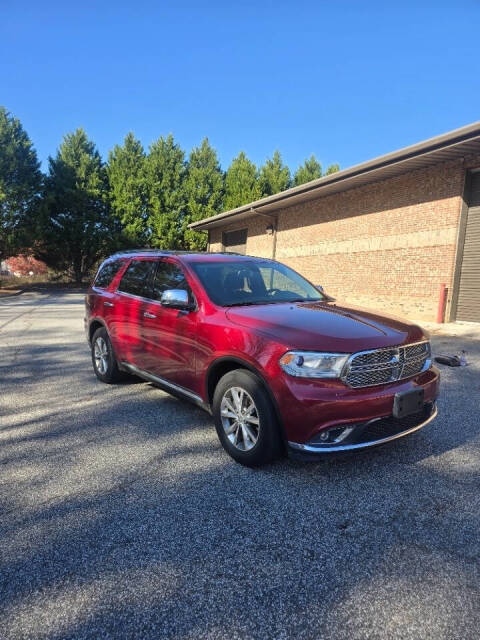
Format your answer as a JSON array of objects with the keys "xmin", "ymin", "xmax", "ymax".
[{"xmin": 190, "ymin": 122, "xmax": 480, "ymax": 322}]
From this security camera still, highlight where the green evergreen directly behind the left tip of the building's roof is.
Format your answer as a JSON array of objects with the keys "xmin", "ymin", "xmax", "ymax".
[{"xmin": 182, "ymin": 138, "xmax": 224, "ymax": 250}]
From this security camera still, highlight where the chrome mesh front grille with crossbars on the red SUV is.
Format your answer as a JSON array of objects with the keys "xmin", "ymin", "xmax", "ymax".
[{"xmin": 342, "ymin": 342, "xmax": 430, "ymax": 387}]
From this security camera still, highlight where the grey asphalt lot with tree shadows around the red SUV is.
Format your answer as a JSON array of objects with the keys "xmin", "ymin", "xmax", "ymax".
[{"xmin": 0, "ymin": 293, "xmax": 480, "ymax": 640}]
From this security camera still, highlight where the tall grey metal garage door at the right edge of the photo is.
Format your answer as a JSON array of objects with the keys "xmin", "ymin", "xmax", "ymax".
[{"xmin": 457, "ymin": 173, "xmax": 480, "ymax": 322}]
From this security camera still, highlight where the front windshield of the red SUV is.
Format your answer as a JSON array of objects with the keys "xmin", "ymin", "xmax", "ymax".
[{"xmin": 190, "ymin": 260, "xmax": 325, "ymax": 307}]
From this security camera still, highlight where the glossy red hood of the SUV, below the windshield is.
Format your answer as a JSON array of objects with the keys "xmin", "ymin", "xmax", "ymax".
[{"xmin": 226, "ymin": 302, "xmax": 428, "ymax": 353}]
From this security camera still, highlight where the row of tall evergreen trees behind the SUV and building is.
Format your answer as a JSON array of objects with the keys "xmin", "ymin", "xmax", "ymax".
[{"xmin": 0, "ymin": 107, "xmax": 339, "ymax": 282}]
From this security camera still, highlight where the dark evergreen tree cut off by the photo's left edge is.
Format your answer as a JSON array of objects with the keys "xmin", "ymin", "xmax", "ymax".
[{"xmin": 0, "ymin": 107, "xmax": 42, "ymax": 260}]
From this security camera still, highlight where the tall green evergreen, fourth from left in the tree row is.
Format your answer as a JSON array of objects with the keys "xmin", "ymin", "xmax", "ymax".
[{"xmin": 146, "ymin": 134, "xmax": 187, "ymax": 249}]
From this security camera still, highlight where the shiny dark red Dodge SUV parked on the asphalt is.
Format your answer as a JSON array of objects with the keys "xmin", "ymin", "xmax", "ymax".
[{"xmin": 85, "ymin": 250, "xmax": 439, "ymax": 466}]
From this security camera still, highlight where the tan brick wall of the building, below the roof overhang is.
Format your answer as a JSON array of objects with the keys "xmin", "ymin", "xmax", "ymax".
[{"xmin": 210, "ymin": 159, "xmax": 480, "ymax": 321}]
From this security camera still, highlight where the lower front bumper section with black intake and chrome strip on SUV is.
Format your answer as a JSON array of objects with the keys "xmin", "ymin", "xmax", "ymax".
[{"xmin": 288, "ymin": 402, "xmax": 438, "ymax": 459}]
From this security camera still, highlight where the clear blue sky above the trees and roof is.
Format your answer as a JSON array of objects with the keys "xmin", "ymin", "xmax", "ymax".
[{"xmin": 0, "ymin": 0, "xmax": 480, "ymax": 169}]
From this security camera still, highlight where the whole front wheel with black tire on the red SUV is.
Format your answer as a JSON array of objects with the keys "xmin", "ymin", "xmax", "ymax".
[{"xmin": 212, "ymin": 369, "xmax": 281, "ymax": 467}]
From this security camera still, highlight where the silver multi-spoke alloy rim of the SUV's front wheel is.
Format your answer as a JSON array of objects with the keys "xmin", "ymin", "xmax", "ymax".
[{"xmin": 220, "ymin": 387, "xmax": 260, "ymax": 451}]
